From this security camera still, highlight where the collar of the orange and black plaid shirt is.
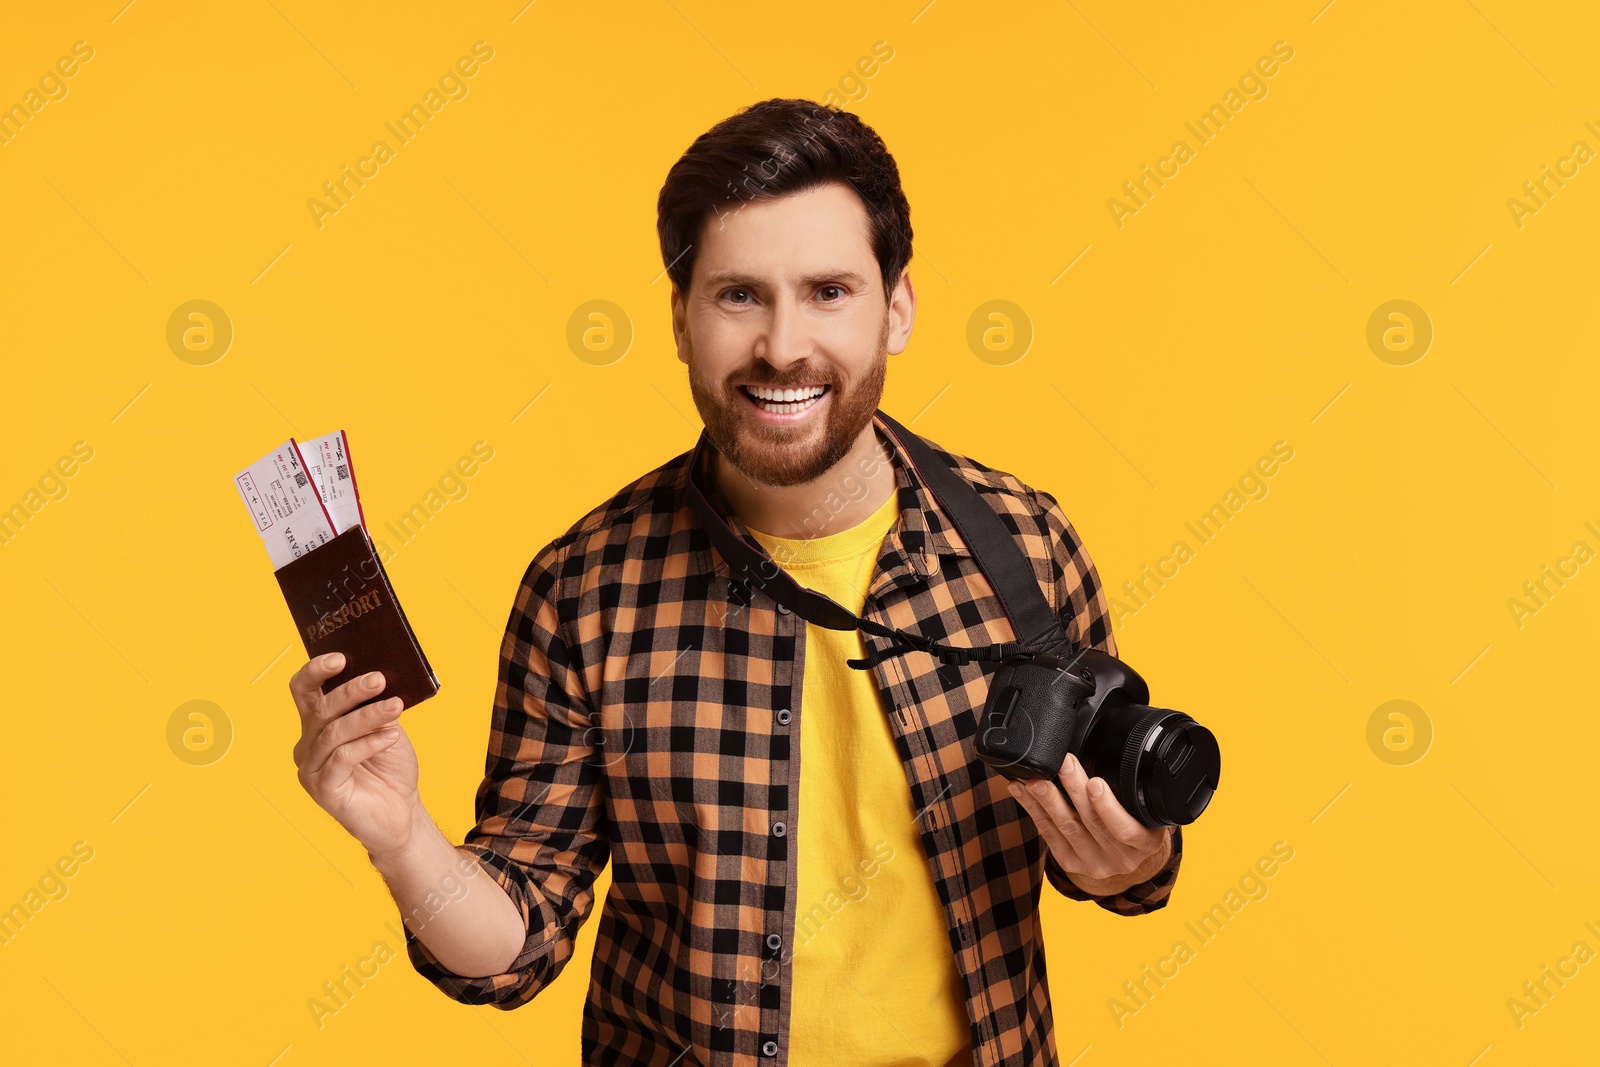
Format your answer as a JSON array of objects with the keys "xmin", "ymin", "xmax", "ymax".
[{"xmin": 678, "ymin": 414, "xmax": 971, "ymax": 590}]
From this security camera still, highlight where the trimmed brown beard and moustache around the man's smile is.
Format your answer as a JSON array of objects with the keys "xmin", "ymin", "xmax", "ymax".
[{"xmin": 685, "ymin": 312, "xmax": 890, "ymax": 486}]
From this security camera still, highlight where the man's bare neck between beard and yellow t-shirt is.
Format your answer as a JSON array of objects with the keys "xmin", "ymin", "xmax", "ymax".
[{"xmin": 712, "ymin": 422, "xmax": 894, "ymax": 539}]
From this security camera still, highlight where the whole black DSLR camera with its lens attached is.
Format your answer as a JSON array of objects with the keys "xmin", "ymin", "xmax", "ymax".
[{"xmin": 978, "ymin": 648, "xmax": 1222, "ymax": 827}]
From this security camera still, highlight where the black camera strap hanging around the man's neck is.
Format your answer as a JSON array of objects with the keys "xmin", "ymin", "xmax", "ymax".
[{"xmin": 688, "ymin": 411, "xmax": 1070, "ymax": 670}]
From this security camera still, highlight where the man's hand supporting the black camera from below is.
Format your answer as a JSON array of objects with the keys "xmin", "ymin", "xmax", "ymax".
[{"xmin": 1011, "ymin": 753, "xmax": 1173, "ymax": 896}]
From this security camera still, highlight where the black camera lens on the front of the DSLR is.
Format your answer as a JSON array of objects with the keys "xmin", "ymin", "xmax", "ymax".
[{"xmin": 1080, "ymin": 704, "xmax": 1222, "ymax": 827}]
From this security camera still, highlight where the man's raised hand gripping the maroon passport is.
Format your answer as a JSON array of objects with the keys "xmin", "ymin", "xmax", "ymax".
[{"xmin": 290, "ymin": 653, "xmax": 426, "ymax": 856}]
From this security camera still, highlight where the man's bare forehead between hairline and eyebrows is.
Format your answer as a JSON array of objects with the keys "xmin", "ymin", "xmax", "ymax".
[{"xmin": 691, "ymin": 182, "xmax": 877, "ymax": 285}]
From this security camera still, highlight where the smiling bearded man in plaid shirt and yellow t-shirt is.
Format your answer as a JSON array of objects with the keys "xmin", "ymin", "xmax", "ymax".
[{"xmin": 290, "ymin": 99, "xmax": 1182, "ymax": 1067}]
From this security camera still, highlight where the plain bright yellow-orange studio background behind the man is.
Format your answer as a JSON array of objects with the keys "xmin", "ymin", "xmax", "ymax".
[{"xmin": 0, "ymin": 0, "xmax": 1600, "ymax": 1067}]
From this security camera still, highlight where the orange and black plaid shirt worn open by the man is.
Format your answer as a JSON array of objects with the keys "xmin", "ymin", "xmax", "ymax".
[{"xmin": 405, "ymin": 406, "xmax": 1182, "ymax": 1067}]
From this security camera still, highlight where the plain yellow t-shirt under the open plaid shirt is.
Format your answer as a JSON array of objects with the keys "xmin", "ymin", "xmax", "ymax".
[{"xmin": 750, "ymin": 491, "xmax": 971, "ymax": 1067}]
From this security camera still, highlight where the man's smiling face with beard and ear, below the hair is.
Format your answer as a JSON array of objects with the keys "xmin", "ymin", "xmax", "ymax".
[{"xmin": 672, "ymin": 182, "xmax": 915, "ymax": 486}]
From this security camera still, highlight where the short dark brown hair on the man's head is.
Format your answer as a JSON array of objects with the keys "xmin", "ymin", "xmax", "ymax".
[{"xmin": 656, "ymin": 98, "xmax": 912, "ymax": 301}]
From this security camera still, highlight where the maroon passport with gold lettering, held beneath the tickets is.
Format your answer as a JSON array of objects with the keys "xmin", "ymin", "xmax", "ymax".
[{"xmin": 274, "ymin": 525, "xmax": 438, "ymax": 707}]
